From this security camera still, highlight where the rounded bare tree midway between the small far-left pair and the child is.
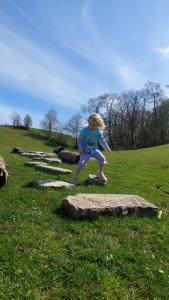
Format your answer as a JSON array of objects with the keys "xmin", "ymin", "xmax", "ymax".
[{"xmin": 40, "ymin": 109, "xmax": 59, "ymax": 138}]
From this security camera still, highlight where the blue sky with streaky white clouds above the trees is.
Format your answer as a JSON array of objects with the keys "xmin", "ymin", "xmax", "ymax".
[{"xmin": 0, "ymin": 0, "xmax": 169, "ymax": 127}]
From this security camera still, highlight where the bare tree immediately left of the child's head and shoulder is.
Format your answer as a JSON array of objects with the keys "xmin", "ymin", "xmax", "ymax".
[{"xmin": 65, "ymin": 113, "xmax": 83, "ymax": 147}]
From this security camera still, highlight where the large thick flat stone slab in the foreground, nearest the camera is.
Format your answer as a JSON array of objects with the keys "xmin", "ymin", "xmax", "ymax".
[{"xmin": 62, "ymin": 194, "xmax": 158, "ymax": 218}]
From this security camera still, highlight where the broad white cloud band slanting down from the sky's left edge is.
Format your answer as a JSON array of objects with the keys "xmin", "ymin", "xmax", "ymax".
[{"xmin": 0, "ymin": 25, "xmax": 92, "ymax": 107}]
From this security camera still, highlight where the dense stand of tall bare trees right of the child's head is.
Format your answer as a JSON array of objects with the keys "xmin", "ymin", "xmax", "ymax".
[{"xmin": 82, "ymin": 81, "xmax": 169, "ymax": 149}]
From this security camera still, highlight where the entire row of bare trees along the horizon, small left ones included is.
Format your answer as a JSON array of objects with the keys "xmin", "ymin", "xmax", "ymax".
[{"xmin": 7, "ymin": 81, "xmax": 169, "ymax": 149}]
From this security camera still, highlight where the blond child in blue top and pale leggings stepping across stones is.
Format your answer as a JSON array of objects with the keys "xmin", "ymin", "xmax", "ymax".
[{"xmin": 71, "ymin": 114, "xmax": 112, "ymax": 184}]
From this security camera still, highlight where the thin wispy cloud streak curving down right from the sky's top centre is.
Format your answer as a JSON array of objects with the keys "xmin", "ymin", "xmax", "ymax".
[{"xmin": 78, "ymin": 0, "xmax": 145, "ymax": 88}]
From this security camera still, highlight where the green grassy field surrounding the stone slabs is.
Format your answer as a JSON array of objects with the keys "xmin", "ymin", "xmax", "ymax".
[{"xmin": 0, "ymin": 126, "xmax": 169, "ymax": 300}]
